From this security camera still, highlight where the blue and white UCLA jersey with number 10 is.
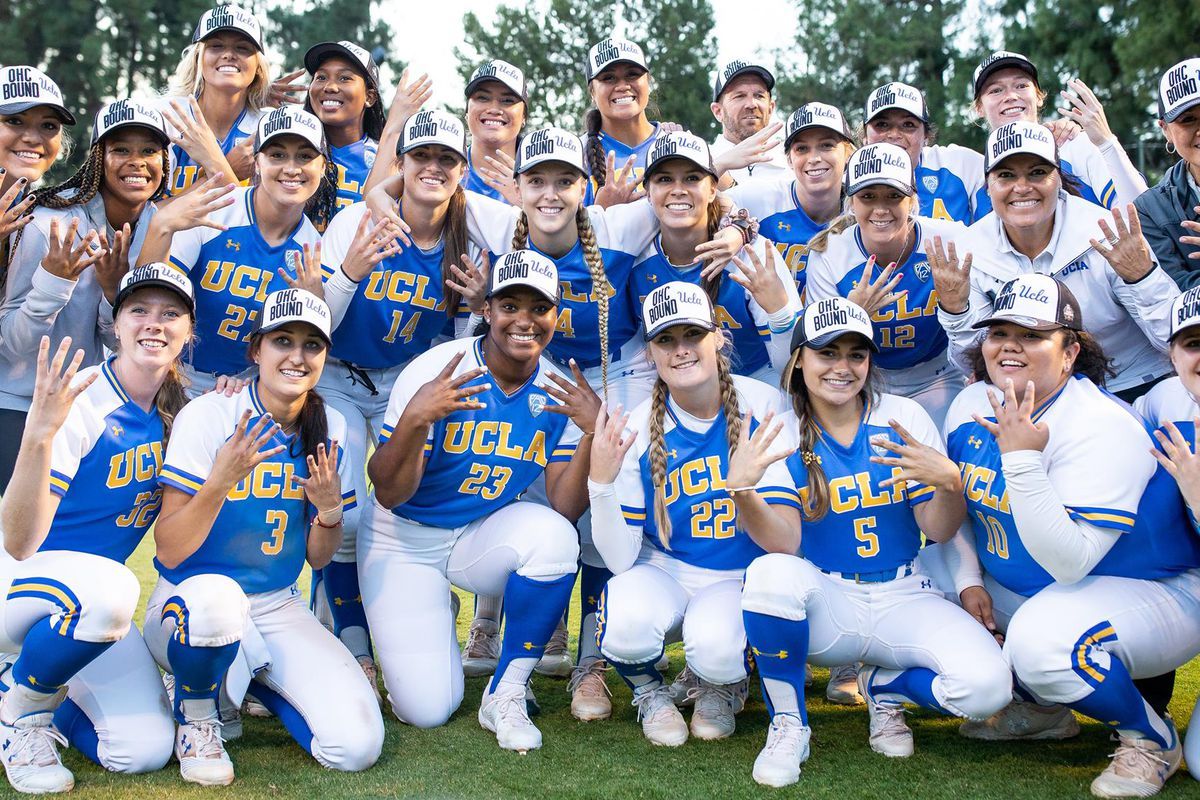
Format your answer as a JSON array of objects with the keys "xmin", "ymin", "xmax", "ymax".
[{"xmin": 946, "ymin": 375, "xmax": 1200, "ymax": 596}]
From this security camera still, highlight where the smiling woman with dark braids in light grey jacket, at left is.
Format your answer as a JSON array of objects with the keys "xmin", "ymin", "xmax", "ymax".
[{"xmin": 0, "ymin": 100, "xmax": 167, "ymax": 489}]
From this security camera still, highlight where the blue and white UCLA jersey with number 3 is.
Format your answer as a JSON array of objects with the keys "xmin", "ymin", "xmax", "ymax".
[{"xmin": 155, "ymin": 379, "xmax": 352, "ymax": 594}]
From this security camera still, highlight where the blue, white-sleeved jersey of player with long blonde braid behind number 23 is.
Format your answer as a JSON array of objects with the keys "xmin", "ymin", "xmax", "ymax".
[{"xmin": 467, "ymin": 192, "xmax": 659, "ymax": 369}]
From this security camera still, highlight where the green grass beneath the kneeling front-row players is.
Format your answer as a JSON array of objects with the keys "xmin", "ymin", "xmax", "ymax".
[{"xmin": 46, "ymin": 537, "xmax": 1200, "ymax": 800}]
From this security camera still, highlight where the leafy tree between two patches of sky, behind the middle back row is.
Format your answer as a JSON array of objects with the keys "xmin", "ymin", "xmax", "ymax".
[{"xmin": 455, "ymin": 0, "xmax": 716, "ymax": 138}]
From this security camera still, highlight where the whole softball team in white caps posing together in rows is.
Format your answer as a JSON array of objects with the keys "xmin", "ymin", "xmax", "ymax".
[{"xmin": 0, "ymin": 6, "xmax": 1200, "ymax": 798}]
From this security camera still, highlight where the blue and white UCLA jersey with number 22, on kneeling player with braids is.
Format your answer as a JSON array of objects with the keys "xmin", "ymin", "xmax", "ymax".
[{"xmin": 616, "ymin": 375, "xmax": 799, "ymax": 570}]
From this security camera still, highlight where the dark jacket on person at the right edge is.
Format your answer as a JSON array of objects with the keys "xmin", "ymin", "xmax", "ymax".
[{"xmin": 1134, "ymin": 160, "xmax": 1200, "ymax": 291}]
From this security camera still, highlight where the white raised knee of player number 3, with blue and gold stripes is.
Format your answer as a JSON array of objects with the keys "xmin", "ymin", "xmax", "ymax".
[{"xmin": 162, "ymin": 575, "xmax": 250, "ymax": 648}]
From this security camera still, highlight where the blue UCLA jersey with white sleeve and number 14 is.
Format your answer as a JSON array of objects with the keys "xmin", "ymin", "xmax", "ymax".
[{"xmin": 320, "ymin": 203, "xmax": 478, "ymax": 369}]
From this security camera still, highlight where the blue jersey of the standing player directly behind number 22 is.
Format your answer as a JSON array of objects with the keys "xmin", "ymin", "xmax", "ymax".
[{"xmin": 629, "ymin": 237, "xmax": 799, "ymax": 375}]
